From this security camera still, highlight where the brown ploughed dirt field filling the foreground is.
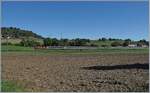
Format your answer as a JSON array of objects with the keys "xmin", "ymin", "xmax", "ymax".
[{"xmin": 2, "ymin": 54, "xmax": 149, "ymax": 92}]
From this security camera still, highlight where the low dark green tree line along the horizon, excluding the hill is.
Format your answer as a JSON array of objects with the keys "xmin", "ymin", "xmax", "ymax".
[{"xmin": 2, "ymin": 38, "xmax": 149, "ymax": 47}]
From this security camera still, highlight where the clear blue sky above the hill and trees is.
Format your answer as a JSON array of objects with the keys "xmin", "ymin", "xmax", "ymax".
[{"xmin": 2, "ymin": 1, "xmax": 148, "ymax": 40}]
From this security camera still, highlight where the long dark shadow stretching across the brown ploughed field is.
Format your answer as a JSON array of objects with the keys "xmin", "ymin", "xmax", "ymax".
[{"xmin": 81, "ymin": 63, "xmax": 149, "ymax": 70}]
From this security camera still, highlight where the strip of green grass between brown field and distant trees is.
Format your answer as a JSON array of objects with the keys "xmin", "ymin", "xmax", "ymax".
[{"xmin": 1, "ymin": 46, "xmax": 149, "ymax": 55}]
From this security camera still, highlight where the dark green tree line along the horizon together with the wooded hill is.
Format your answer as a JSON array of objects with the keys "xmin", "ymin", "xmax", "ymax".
[{"xmin": 1, "ymin": 27, "xmax": 149, "ymax": 47}]
